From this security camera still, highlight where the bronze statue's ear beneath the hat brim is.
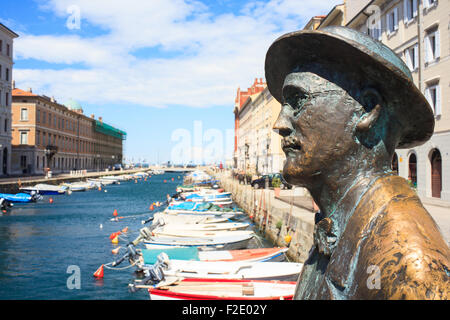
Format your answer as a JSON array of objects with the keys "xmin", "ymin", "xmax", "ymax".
[{"xmin": 356, "ymin": 88, "xmax": 383, "ymax": 133}]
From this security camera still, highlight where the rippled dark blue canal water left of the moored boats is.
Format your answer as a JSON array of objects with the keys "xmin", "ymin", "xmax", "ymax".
[{"xmin": 0, "ymin": 173, "xmax": 267, "ymax": 300}]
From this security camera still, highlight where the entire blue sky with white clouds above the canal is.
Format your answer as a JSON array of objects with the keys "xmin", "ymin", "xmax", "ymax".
[{"xmin": 0, "ymin": 0, "xmax": 342, "ymax": 163}]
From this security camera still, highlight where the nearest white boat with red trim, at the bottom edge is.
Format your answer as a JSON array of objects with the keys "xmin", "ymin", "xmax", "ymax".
[{"xmin": 144, "ymin": 278, "xmax": 296, "ymax": 300}]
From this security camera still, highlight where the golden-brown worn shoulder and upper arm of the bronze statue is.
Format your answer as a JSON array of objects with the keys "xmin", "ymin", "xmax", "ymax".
[{"xmin": 355, "ymin": 177, "xmax": 450, "ymax": 299}]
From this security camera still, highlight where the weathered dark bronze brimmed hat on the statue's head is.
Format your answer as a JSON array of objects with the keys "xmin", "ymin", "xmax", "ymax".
[{"xmin": 265, "ymin": 27, "xmax": 434, "ymax": 148}]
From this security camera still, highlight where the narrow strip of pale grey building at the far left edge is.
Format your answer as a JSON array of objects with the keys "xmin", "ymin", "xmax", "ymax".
[{"xmin": 0, "ymin": 23, "xmax": 18, "ymax": 176}]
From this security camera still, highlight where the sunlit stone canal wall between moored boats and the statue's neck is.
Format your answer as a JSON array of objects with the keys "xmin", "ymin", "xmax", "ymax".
[{"xmin": 215, "ymin": 173, "xmax": 314, "ymax": 262}]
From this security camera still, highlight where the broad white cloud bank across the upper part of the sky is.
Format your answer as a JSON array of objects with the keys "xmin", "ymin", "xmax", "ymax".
[{"xmin": 14, "ymin": 0, "xmax": 340, "ymax": 107}]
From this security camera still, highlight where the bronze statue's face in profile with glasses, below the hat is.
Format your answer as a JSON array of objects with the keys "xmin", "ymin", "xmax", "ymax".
[{"xmin": 274, "ymin": 72, "xmax": 358, "ymax": 187}]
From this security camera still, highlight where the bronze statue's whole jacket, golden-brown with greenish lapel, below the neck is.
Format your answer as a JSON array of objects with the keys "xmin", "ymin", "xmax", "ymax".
[{"xmin": 295, "ymin": 176, "xmax": 450, "ymax": 300}]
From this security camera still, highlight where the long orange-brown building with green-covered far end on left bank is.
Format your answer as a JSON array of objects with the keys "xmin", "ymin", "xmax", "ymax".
[{"xmin": 11, "ymin": 88, "xmax": 126, "ymax": 174}]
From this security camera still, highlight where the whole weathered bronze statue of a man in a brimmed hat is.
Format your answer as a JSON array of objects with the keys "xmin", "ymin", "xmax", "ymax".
[{"xmin": 265, "ymin": 27, "xmax": 450, "ymax": 299}]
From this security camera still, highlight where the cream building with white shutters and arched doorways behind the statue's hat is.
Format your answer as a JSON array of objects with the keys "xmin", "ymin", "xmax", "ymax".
[{"xmin": 346, "ymin": 0, "xmax": 450, "ymax": 201}]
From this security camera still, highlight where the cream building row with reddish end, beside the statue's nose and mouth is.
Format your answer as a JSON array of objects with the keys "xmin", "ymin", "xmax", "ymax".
[{"xmin": 234, "ymin": 79, "xmax": 285, "ymax": 175}]
